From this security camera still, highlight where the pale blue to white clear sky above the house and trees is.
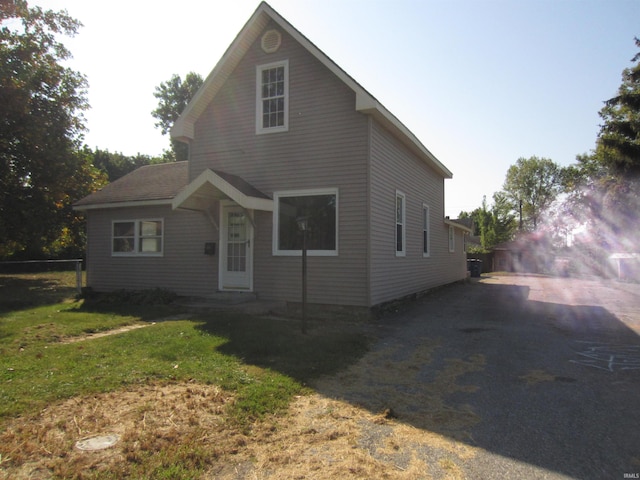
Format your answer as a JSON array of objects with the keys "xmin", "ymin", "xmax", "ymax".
[{"xmin": 45, "ymin": 0, "xmax": 640, "ymax": 218}]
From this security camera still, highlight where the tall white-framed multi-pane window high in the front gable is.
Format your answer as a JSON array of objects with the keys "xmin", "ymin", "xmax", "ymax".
[{"xmin": 256, "ymin": 60, "xmax": 289, "ymax": 133}]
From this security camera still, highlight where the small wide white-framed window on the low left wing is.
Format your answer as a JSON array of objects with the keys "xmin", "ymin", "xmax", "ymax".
[{"xmin": 111, "ymin": 219, "xmax": 164, "ymax": 256}]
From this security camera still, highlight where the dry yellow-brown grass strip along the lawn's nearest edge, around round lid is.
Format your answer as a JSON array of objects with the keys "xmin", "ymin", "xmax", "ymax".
[{"xmin": 0, "ymin": 384, "xmax": 475, "ymax": 480}]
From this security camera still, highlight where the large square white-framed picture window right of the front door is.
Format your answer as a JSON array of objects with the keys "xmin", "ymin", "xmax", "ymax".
[{"xmin": 273, "ymin": 188, "xmax": 338, "ymax": 256}]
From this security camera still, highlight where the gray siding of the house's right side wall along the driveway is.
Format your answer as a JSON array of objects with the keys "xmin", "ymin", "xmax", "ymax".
[{"xmin": 370, "ymin": 120, "xmax": 466, "ymax": 305}]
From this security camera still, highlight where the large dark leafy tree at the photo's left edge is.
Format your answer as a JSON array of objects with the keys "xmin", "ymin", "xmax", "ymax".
[{"xmin": 0, "ymin": 0, "xmax": 100, "ymax": 257}]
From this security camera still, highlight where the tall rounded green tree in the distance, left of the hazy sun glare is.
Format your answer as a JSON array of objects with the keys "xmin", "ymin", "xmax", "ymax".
[{"xmin": 502, "ymin": 157, "xmax": 561, "ymax": 231}]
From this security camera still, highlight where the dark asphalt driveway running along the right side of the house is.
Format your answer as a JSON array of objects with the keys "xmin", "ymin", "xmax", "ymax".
[{"xmin": 318, "ymin": 276, "xmax": 640, "ymax": 479}]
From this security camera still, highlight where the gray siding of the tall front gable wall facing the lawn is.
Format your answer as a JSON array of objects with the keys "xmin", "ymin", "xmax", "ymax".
[{"xmin": 190, "ymin": 25, "xmax": 369, "ymax": 306}]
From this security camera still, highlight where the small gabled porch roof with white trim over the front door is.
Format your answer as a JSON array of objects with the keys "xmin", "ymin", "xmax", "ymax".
[{"xmin": 171, "ymin": 169, "xmax": 273, "ymax": 212}]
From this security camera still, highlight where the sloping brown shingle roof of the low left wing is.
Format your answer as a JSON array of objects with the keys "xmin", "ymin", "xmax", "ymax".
[{"xmin": 74, "ymin": 162, "xmax": 189, "ymax": 210}]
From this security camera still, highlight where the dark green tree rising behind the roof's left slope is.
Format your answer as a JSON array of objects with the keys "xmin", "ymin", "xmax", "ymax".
[{"xmin": 151, "ymin": 72, "xmax": 203, "ymax": 161}]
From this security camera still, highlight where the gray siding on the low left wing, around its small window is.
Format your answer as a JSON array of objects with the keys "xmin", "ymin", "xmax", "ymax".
[{"xmin": 87, "ymin": 206, "xmax": 218, "ymax": 296}]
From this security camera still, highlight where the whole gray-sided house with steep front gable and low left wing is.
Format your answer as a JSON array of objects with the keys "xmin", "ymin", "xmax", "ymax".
[{"xmin": 75, "ymin": 2, "xmax": 470, "ymax": 309}]
